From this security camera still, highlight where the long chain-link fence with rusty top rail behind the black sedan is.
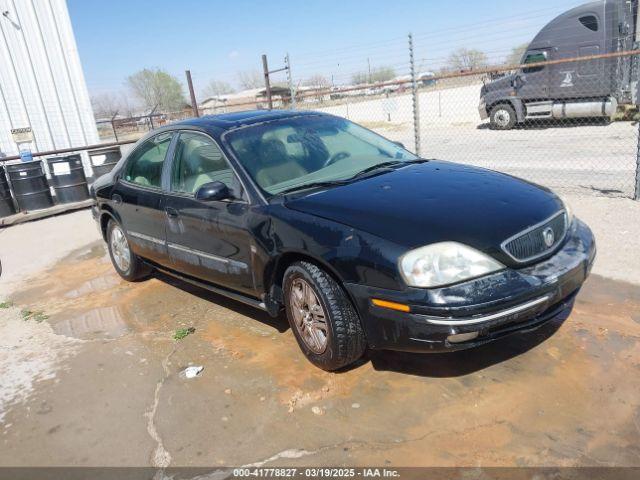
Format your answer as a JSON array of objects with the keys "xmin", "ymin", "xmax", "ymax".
[{"xmin": 92, "ymin": 50, "xmax": 640, "ymax": 198}]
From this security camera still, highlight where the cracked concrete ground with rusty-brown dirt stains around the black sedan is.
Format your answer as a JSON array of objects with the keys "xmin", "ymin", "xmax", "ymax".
[{"xmin": 0, "ymin": 212, "xmax": 640, "ymax": 467}]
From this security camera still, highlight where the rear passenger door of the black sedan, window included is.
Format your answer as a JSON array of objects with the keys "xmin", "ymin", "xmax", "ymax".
[{"xmin": 112, "ymin": 132, "xmax": 173, "ymax": 265}]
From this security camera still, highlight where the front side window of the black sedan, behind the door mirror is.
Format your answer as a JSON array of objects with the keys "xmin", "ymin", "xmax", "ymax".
[{"xmin": 171, "ymin": 132, "xmax": 241, "ymax": 197}]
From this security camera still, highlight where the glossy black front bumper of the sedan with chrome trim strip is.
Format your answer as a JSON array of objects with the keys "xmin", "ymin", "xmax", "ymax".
[{"xmin": 346, "ymin": 219, "xmax": 596, "ymax": 352}]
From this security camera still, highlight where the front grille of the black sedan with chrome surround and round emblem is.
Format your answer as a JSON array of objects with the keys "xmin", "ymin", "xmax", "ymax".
[{"xmin": 502, "ymin": 211, "xmax": 567, "ymax": 262}]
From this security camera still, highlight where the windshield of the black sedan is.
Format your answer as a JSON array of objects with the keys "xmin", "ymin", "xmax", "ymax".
[{"xmin": 227, "ymin": 115, "xmax": 418, "ymax": 195}]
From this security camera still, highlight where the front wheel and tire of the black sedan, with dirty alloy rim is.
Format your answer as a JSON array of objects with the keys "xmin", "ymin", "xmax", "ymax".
[{"xmin": 283, "ymin": 262, "xmax": 366, "ymax": 371}]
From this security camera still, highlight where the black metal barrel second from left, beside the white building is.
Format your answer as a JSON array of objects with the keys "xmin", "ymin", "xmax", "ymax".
[{"xmin": 6, "ymin": 161, "xmax": 53, "ymax": 212}]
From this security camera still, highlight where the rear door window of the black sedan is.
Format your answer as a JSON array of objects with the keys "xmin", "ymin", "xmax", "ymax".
[{"xmin": 124, "ymin": 132, "xmax": 173, "ymax": 188}]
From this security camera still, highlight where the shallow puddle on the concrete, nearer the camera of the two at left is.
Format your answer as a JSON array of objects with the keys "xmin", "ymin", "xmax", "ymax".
[{"xmin": 51, "ymin": 306, "xmax": 130, "ymax": 340}]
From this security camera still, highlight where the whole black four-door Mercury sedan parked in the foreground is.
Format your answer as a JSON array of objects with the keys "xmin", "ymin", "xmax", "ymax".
[{"xmin": 92, "ymin": 111, "xmax": 595, "ymax": 370}]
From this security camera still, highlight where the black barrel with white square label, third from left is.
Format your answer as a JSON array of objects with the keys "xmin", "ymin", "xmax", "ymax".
[{"xmin": 47, "ymin": 155, "xmax": 89, "ymax": 203}]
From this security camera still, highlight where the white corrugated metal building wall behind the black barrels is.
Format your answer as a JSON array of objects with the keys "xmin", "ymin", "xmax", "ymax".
[{"xmin": 0, "ymin": 0, "xmax": 99, "ymax": 163}]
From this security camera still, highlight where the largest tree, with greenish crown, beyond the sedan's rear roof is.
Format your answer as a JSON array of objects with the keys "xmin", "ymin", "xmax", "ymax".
[{"xmin": 127, "ymin": 68, "xmax": 186, "ymax": 111}]
